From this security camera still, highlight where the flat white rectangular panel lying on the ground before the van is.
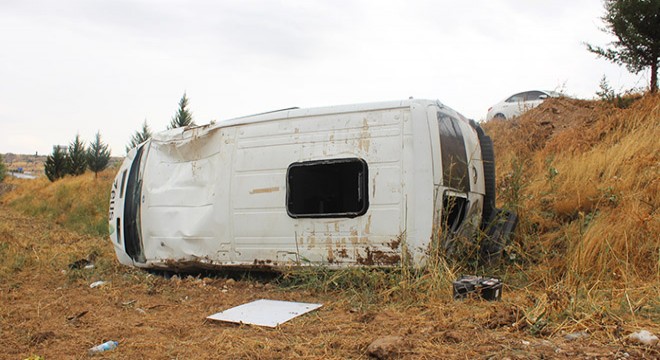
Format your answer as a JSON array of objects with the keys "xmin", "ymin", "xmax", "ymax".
[{"xmin": 207, "ymin": 299, "xmax": 323, "ymax": 327}]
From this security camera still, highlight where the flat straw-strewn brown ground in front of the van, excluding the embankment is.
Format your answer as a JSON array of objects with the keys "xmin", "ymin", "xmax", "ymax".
[{"xmin": 0, "ymin": 205, "xmax": 660, "ymax": 359}]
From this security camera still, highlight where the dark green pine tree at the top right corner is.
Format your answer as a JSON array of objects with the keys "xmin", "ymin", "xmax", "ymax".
[{"xmin": 587, "ymin": 0, "xmax": 660, "ymax": 92}]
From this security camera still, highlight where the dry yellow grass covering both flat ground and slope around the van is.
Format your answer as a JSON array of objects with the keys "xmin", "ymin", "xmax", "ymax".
[{"xmin": 0, "ymin": 97, "xmax": 660, "ymax": 359}]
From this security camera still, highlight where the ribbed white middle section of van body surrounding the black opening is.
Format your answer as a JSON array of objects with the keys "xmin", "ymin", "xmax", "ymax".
[{"xmin": 230, "ymin": 108, "xmax": 409, "ymax": 265}]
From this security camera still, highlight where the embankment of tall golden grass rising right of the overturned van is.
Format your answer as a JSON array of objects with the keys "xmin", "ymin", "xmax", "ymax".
[{"xmin": 484, "ymin": 95, "xmax": 660, "ymax": 281}]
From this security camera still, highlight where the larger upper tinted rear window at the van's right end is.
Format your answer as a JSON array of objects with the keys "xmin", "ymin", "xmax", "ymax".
[{"xmin": 438, "ymin": 112, "xmax": 470, "ymax": 192}]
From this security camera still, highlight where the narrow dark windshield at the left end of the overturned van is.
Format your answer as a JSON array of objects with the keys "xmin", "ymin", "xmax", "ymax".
[{"xmin": 124, "ymin": 145, "xmax": 146, "ymax": 262}]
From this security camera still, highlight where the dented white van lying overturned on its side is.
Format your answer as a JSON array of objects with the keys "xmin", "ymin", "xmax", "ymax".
[{"xmin": 109, "ymin": 99, "xmax": 516, "ymax": 270}]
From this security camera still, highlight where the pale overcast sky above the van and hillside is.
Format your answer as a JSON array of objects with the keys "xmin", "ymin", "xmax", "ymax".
[{"xmin": 0, "ymin": 0, "xmax": 648, "ymax": 156}]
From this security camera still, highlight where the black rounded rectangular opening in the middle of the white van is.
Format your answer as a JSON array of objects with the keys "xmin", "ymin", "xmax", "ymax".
[{"xmin": 286, "ymin": 158, "xmax": 369, "ymax": 218}]
